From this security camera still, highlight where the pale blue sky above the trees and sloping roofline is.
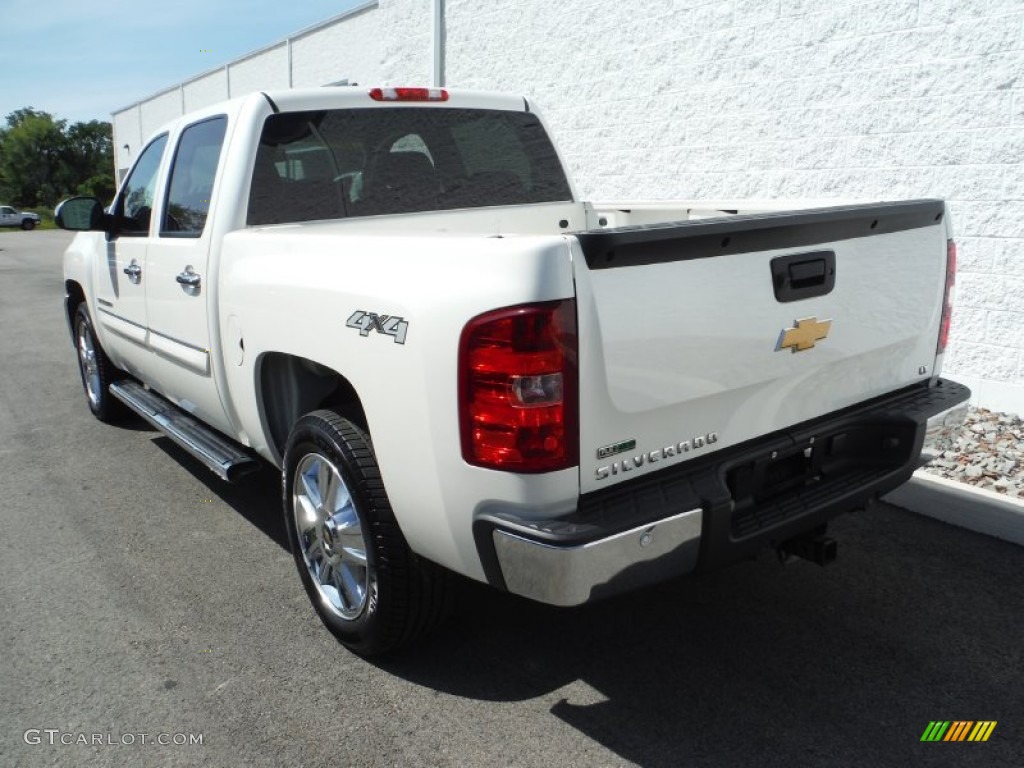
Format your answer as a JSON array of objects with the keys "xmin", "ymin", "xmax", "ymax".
[{"xmin": 0, "ymin": 0, "xmax": 366, "ymax": 123}]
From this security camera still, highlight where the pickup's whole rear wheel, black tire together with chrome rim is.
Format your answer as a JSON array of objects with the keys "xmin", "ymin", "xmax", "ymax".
[{"xmin": 282, "ymin": 411, "xmax": 452, "ymax": 656}]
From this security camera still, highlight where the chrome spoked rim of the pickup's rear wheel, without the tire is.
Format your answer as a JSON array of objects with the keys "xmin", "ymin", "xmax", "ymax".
[{"xmin": 292, "ymin": 454, "xmax": 371, "ymax": 621}]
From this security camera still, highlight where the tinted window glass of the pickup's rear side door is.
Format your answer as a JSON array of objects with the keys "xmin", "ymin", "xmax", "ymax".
[{"xmin": 160, "ymin": 117, "xmax": 227, "ymax": 238}]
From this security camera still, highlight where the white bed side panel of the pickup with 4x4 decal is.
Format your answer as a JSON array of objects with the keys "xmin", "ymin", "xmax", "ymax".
[{"xmin": 220, "ymin": 228, "xmax": 579, "ymax": 579}]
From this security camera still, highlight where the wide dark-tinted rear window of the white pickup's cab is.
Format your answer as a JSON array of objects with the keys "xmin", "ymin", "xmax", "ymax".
[{"xmin": 247, "ymin": 108, "xmax": 571, "ymax": 225}]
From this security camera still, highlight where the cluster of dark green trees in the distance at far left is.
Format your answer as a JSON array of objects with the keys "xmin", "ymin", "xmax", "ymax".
[{"xmin": 0, "ymin": 108, "xmax": 115, "ymax": 208}]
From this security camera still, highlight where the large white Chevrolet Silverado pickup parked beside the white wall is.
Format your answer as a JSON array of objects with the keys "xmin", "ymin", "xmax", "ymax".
[{"xmin": 56, "ymin": 87, "xmax": 970, "ymax": 654}]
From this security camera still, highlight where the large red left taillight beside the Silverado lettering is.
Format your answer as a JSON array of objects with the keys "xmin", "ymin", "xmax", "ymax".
[{"xmin": 459, "ymin": 299, "xmax": 580, "ymax": 472}]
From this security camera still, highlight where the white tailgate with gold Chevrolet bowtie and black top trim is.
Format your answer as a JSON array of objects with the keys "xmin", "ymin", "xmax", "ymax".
[{"xmin": 573, "ymin": 200, "xmax": 947, "ymax": 493}]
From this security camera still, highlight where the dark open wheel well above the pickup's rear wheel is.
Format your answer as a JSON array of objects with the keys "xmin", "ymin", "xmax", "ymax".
[{"xmin": 256, "ymin": 352, "xmax": 370, "ymax": 463}]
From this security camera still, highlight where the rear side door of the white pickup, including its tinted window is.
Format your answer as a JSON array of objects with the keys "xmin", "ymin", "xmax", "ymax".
[{"xmin": 145, "ymin": 115, "xmax": 230, "ymax": 431}]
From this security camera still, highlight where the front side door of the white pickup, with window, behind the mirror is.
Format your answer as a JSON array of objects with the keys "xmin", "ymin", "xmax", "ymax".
[{"xmin": 94, "ymin": 133, "xmax": 167, "ymax": 380}]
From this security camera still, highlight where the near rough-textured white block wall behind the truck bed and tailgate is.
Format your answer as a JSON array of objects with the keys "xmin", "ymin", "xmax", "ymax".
[{"xmin": 381, "ymin": 0, "xmax": 1024, "ymax": 413}]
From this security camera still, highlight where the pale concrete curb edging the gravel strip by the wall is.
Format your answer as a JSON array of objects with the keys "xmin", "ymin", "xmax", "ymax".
[{"xmin": 883, "ymin": 469, "xmax": 1024, "ymax": 546}]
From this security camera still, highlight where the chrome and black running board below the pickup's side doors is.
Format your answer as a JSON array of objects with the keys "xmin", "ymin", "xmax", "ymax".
[{"xmin": 111, "ymin": 381, "xmax": 259, "ymax": 482}]
